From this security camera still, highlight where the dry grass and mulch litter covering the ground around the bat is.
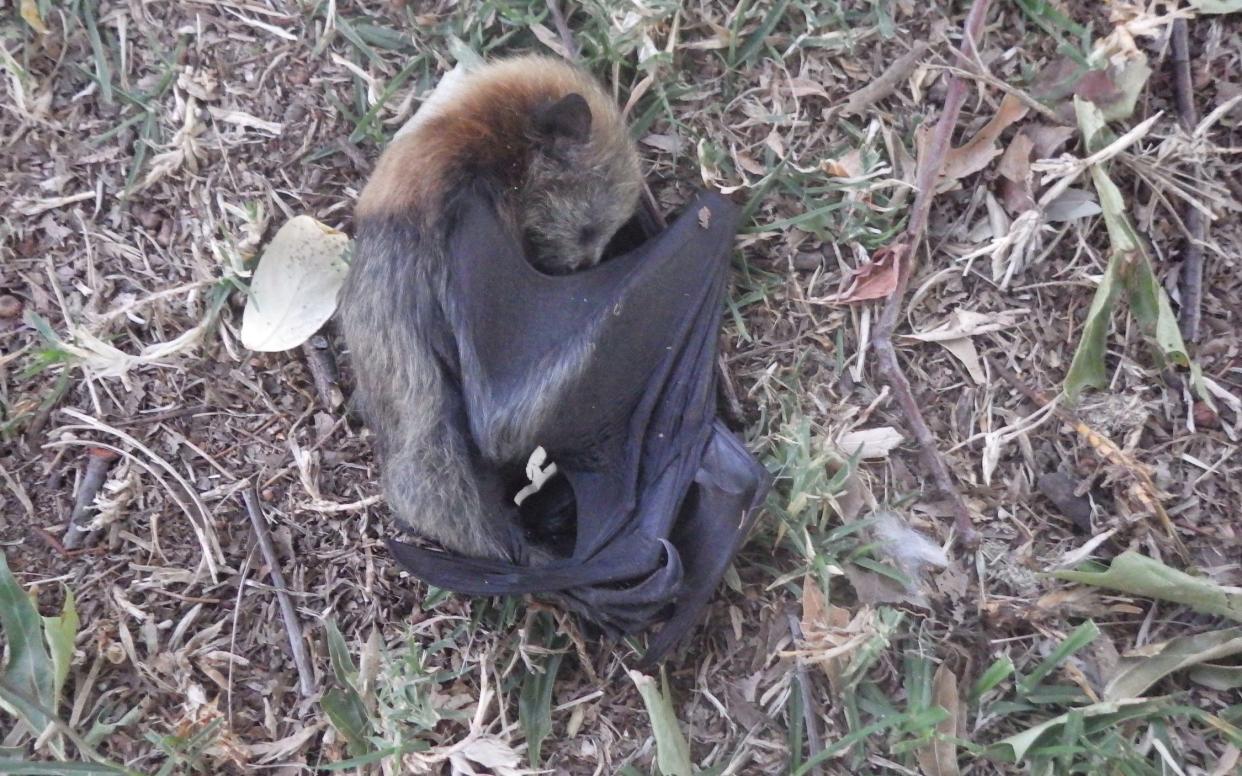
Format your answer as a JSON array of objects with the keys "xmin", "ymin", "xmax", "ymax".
[{"xmin": 0, "ymin": 0, "xmax": 1242, "ymax": 774}]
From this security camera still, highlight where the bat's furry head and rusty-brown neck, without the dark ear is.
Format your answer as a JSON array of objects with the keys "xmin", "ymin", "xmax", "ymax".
[{"xmin": 356, "ymin": 56, "xmax": 641, "ymax": 271}]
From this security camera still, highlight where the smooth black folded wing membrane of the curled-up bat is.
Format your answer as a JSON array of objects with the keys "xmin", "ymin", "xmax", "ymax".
[{"xmin": 390, "ymin": 187, "xmax": 769, "ymax": 662}]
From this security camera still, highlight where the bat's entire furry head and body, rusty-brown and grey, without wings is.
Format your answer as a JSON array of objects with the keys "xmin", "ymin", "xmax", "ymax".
[{"xmin": 340, "ymin": 57, "xmax": 641, "ymax": 560}]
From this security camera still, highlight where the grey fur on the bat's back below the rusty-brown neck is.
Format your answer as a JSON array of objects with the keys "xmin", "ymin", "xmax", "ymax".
[{"xmin": 340, "ymin": 219, "xmax": 513, "ymax": 557}]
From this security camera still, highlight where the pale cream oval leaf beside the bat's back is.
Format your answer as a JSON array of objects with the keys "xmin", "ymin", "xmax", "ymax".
[{"xmin": 241, "ymin": 216, "xmax": 349, "ymax": 353}]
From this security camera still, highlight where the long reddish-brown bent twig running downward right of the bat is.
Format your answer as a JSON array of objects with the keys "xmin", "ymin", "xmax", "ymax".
[{"xmin": 871, "ymin": 0, "xmax": 990, "ymax": 548}]
